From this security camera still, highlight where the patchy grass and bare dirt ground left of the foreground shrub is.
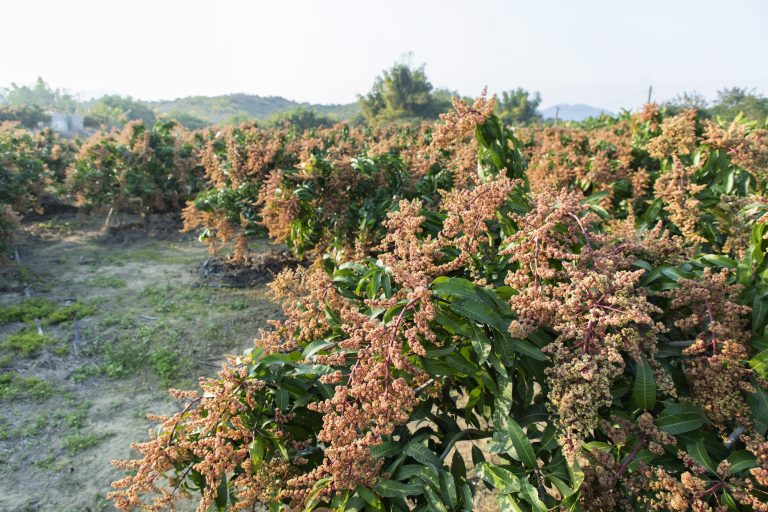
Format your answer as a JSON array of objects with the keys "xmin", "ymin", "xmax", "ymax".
[{"xmin": 0, "ymin": 216, "xmax": 278, "ymax": 512}]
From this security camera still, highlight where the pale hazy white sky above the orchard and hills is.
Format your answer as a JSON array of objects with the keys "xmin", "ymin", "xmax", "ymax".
[{"xmin": 0, "ymin": 0, "xmax": 768, "ymax": 110}]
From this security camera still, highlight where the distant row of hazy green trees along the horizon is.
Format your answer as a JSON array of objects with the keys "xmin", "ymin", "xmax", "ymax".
[{"xmin": 0, "ymin": 70, "xmax": 768, "ymax": 130}]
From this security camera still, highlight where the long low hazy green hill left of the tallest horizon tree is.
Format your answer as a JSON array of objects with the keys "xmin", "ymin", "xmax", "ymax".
[{"xmin": 146, "ymin": 93, "xmax": 358, "ymax": 124}]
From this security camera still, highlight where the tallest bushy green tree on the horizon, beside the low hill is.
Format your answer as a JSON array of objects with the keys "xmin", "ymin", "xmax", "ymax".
[{"xmin": 359, "ymin": 63, "xmax": 451, "ymax": 124}]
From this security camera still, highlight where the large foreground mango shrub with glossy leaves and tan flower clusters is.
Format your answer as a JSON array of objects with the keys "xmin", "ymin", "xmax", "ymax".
[{"xmin": 111, "ymin": 98, "xmax": 768, "ymax": 511}]
